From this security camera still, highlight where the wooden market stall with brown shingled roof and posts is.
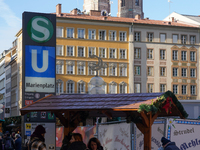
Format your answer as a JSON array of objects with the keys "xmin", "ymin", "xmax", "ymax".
[{"xmin": 20, "ymin": 91, "xmax": 187, "ymax": 150}]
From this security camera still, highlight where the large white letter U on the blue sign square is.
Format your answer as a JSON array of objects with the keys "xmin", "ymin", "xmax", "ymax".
[{"xmin": 32, "ymin": 50, "xmax": 48, "ymax": 72}]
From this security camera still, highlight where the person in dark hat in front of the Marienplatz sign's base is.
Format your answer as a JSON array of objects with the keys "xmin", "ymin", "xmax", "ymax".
[{"xmin": 28, "ymin": 125, "xmax": 46, "ymax": 150}]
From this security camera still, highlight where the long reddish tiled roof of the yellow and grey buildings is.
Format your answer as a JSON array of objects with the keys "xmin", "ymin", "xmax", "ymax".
[{"xmin": 57, "ymin": 13, "xmax": 199, "ymax": 28}]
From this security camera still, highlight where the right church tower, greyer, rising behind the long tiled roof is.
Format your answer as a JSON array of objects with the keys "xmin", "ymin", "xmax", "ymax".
[{"xmin": 117, "ymin": 0, "xmax": 144, "ymax": 19}]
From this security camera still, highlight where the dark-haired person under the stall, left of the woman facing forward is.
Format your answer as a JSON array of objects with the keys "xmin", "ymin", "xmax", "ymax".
[{"xmin": 67, "ymin": 133, "xmax": 86, "ymax": 150}]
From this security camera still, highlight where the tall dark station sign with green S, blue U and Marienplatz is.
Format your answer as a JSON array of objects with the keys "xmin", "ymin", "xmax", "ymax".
[{"xmin": 22, "ymin": 12, "xmax": 56, "ymax": 122}]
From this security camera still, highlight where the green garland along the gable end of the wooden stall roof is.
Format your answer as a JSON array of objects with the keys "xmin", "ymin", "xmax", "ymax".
[{"xmin": 138, "ymin": 91, "xmax": 188, "ymax": 118}]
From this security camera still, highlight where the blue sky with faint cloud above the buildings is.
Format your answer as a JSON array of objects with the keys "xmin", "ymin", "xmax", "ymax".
[{"xmin": 0, "ymin": 0, "xmax": 200, "ymax": 53}]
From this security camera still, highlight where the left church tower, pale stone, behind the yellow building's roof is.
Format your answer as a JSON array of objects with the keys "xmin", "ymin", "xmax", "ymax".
[{"xmin": 83, "ymin": 0, "xmax": 110, "ymax": 14}]
